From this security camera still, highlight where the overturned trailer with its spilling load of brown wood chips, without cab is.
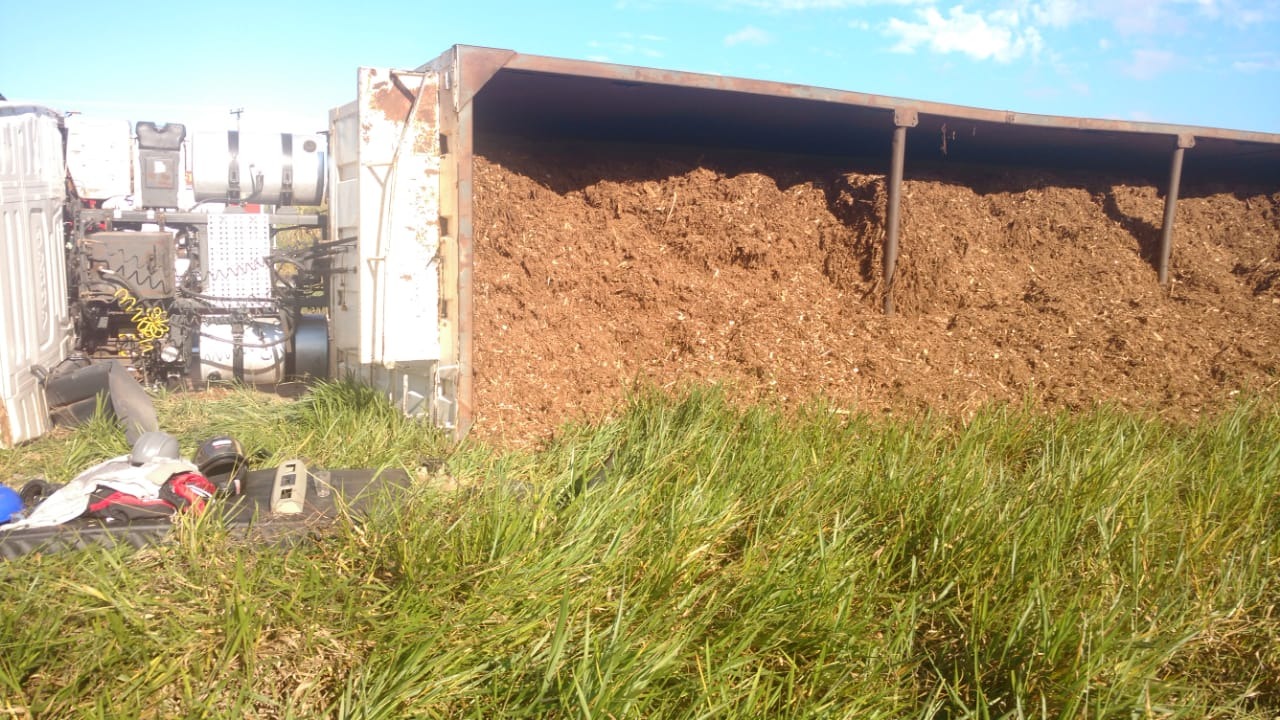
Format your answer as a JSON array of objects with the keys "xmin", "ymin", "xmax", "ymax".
[{"xmin": 330, "ymin": 46, "xmax": 1280, "ymax": 439}]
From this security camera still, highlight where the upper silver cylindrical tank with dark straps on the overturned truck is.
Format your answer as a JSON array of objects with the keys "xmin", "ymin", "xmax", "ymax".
[{"xmin": 191, "ymin": 131, "xmax": 325, "ymax": 205}]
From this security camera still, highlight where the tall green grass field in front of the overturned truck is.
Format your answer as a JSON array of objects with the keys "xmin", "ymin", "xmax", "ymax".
[{"xmin": 0, "ymin": 383, "xmax": 1280, "ymax": 719}]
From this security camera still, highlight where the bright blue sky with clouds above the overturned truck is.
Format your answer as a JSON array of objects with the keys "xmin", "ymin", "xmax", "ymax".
[{"xmin": 0, "ymin": 0, "xmax": 1280, "ymax": 133}]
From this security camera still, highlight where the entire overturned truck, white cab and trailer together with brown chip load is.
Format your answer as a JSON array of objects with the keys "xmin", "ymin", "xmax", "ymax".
[{"xmin": 0, "ymin": 46, "xmax": 1280, "ymax": 445}]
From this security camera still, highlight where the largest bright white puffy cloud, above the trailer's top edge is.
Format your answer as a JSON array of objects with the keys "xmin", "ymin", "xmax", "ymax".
[{"xmin": 884, "ymin": 5, "xmax": 1043, "ymax": 63}]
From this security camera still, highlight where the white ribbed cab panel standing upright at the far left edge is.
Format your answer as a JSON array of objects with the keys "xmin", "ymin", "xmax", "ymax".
[{"xmin": 0, "ymin": 102, "xmax": 72, "ymax": 447}]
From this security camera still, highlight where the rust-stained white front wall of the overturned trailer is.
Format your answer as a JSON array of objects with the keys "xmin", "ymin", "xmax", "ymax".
[{"xmin": 329, "ymin": 68, "xmax": 442, "ymax": 415}]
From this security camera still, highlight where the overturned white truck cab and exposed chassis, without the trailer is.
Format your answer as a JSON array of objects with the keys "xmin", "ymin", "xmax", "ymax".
[{"xmin": 0, "ymin": 102, "xmax": 329, "ymax": 447}]
